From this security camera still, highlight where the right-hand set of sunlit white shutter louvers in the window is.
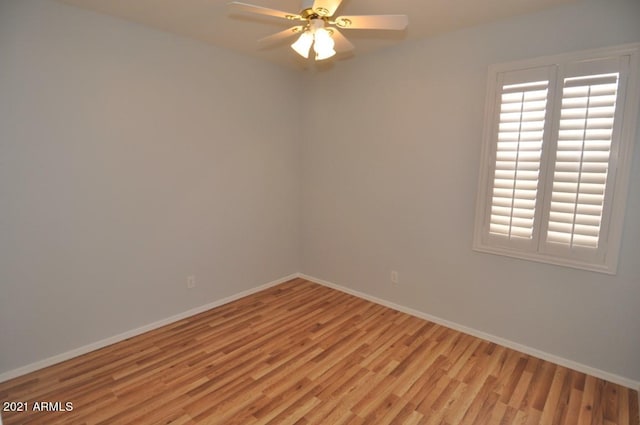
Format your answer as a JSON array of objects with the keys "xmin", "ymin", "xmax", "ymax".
[{"xmin": 547, "ymin": 74, "xmax": 618, "ymax": 249}]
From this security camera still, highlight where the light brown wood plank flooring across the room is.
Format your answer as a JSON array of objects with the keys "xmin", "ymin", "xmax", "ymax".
[{"xmin": 0, "ymin": 279, "xmax": 638, "ymax": 425}]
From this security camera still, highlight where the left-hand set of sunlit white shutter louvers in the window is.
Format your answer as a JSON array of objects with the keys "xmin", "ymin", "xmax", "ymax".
[{"xmin": 489, "ymin": 81, "xmax": 549, "ymax": 239}]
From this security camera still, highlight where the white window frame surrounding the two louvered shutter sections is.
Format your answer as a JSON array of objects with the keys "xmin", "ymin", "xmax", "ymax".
[{"xmin": 472, "ymin": 43, "xmax": 640, "ymax": 274}]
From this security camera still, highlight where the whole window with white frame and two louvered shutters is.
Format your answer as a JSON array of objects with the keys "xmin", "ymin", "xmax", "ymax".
[{"xmin": 474, "ymin": 44, "xmax": 640, "ymax": 274}]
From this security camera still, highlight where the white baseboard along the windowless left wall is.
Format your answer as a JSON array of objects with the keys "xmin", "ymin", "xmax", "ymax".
[{"xmin": 0, "ymin": 273, "xmax": 299, "ymax": 382}]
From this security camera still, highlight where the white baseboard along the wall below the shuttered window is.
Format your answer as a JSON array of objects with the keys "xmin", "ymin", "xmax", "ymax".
[{"xmin": 298, "ymin": 274, "xmax": 640, "ymax": 390}]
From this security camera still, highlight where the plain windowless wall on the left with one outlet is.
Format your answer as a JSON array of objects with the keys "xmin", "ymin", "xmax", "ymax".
[{"xmin": 0, "ymin": 0, "xmax": 300, "ymax": 372}]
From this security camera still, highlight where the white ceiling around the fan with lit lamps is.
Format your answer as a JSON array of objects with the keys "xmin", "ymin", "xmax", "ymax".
[{"xmin": 59, "ymin": 0, "xmax": 581, "ymax": 69}]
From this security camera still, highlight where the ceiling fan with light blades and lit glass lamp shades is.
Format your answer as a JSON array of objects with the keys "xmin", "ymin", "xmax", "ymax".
[{"xmin": 228, "ymin": 0, "xmax": 409, "ymax": 60}]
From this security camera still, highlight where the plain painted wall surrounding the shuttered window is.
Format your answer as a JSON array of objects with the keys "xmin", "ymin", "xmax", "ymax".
[{"xmin": 302, "ymin": 0, "xmax": 640, "ymax": 382}]
